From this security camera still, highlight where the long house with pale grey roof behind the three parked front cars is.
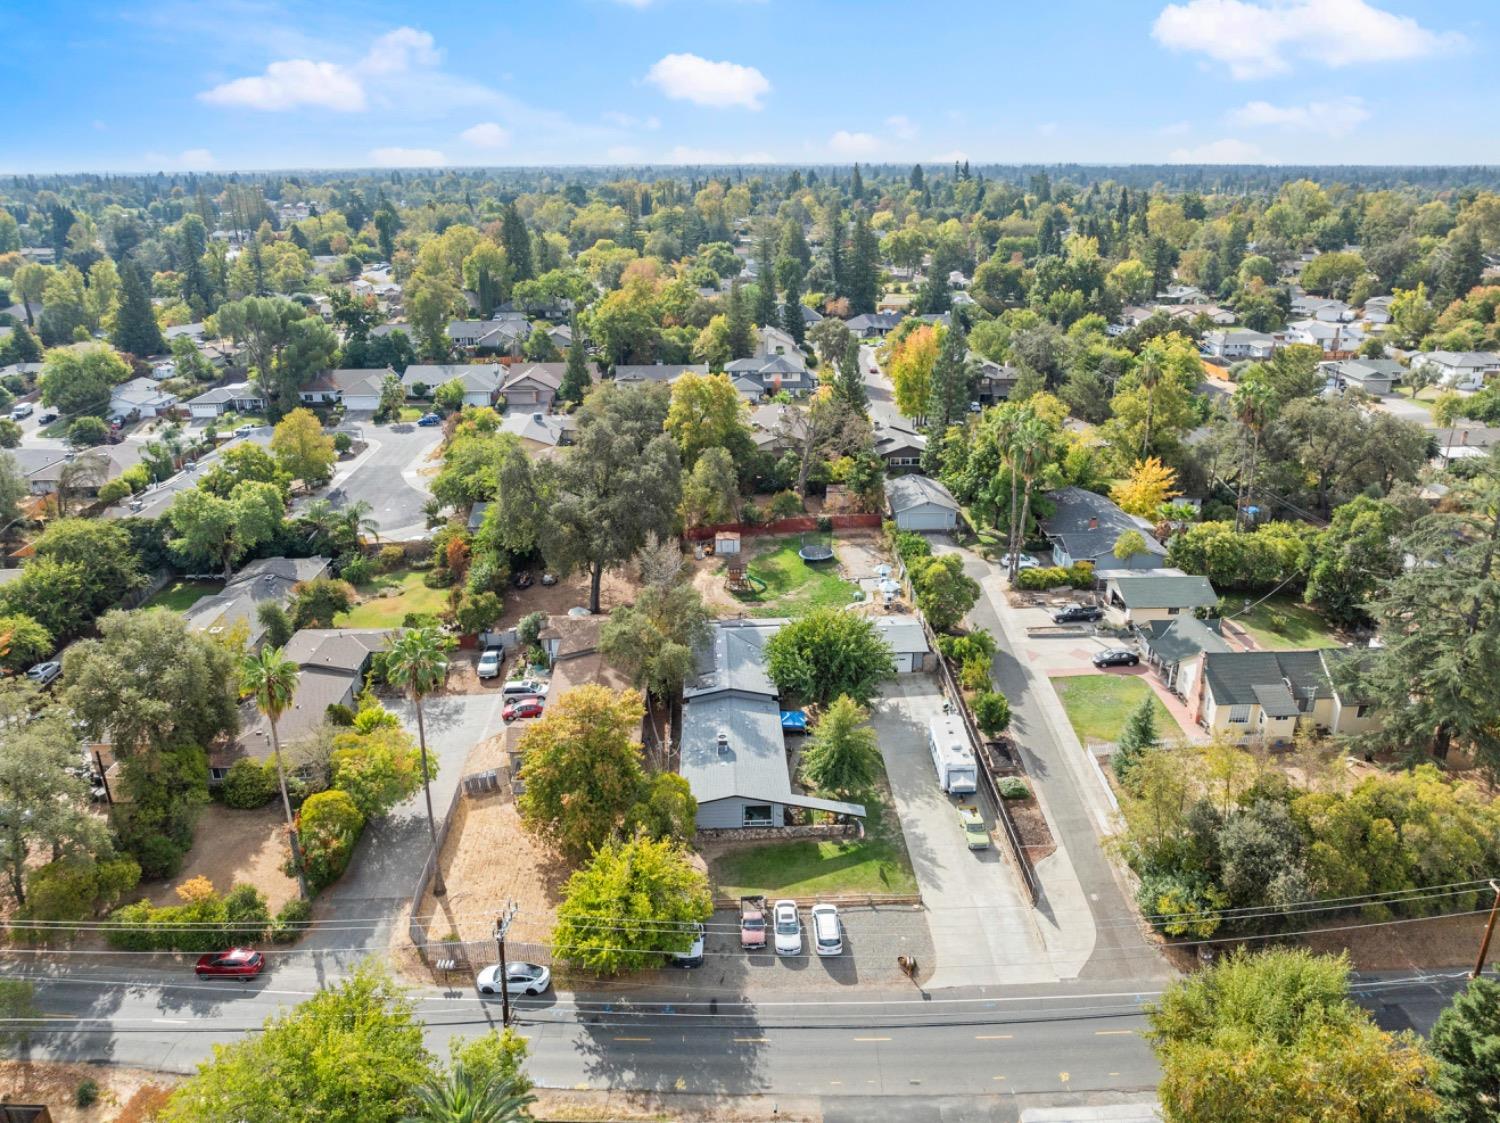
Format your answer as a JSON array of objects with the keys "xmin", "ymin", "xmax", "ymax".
[{"xmin": 678, "ymin": 619, "xmax": 864, "ymax": 831}]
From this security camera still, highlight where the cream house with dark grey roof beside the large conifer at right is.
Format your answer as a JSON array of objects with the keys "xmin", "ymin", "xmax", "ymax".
[{"xmin": 1182, "ymin": 648, "xmax": 1377, "ymax": 745}]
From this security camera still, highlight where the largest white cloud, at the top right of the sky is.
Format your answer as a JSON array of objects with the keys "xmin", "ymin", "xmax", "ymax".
[{"xmin": 1151, "ymin": 0, "xmax": 1464, "ymax": 78}]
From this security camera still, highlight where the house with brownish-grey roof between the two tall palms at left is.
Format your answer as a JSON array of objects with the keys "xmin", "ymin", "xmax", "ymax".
[{"xmin": 219, "ymin": 628, "xmax": 399, "ymax": 781}]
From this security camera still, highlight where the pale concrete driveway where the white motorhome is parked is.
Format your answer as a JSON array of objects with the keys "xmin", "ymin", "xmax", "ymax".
[{"xmin": 872, "ymin": 675, "xmax": 1058, "ymax": 990}]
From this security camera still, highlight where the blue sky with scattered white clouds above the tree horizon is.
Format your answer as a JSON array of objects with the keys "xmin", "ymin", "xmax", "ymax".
[{"xmin": 0, "ymin": 0, "xmax": 1500, "ymax": 171}]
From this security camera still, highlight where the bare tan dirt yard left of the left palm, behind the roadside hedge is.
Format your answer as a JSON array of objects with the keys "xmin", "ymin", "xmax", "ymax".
[{"xmin": 143, "ymin": 799, "xmax": 297, "ymax": 913}]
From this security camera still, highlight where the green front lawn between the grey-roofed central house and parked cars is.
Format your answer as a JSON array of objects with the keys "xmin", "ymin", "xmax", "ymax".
[{"xmin": 708, "ymin": 796, "xmax": 917, "ymax": 897}]
